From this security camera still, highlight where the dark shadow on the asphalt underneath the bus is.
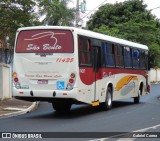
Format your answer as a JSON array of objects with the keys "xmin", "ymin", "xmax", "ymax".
[{"xmin": 23, "ymin": 101, "xmax": 143, "ymax": 119}]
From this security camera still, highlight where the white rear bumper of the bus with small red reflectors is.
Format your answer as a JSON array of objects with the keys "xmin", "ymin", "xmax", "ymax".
[{"xmin": 13, "ymin": 87, "xmax": 78, "ymax": 101}]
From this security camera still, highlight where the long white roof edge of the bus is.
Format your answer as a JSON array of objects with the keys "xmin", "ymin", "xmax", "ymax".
[{"xmin": 18, "ymin": 26, "xmax": 148, "ymax": 50}]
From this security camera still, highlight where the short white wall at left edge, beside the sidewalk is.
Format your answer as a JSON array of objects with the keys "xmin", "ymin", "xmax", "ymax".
[{"xmin": 0, "ymin": 64, "xmax": 11, "ymax": 100}]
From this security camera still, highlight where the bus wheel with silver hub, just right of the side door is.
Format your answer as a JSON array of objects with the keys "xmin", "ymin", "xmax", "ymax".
[{"xmin": 100, "ymin": 87, "xmax": 112, "ymax": 111}]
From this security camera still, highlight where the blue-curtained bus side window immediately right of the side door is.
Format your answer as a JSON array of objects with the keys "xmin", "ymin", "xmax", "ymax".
[{"xmin": 103, "ymin": 42, "xmax": 115, "ymax": 67}]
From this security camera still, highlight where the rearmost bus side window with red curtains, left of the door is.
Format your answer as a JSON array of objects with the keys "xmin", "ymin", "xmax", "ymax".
[{"xmin": 78, "ymin": 37, "xmax": 91, "ymax": 66}]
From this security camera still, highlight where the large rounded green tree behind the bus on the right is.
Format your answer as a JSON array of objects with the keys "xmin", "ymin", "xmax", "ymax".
[{"xmin": 87, "ymin": 0, "xmax": 160, "ymax": 67}]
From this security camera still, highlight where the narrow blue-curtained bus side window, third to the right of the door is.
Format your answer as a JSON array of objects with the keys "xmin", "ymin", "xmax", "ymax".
[{"xmin": 124, "ymin": 47, "xmax": 132, "ymax": 68}]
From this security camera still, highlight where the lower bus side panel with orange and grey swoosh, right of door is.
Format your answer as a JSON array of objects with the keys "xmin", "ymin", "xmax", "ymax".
[{"xmin": 99, "ymin": 69, "xmax": 146, "ymax": 102}]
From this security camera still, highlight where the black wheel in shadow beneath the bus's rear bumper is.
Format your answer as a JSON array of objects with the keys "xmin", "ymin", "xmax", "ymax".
[{"xmin": 52, "ymin": 101, "xmax": 72, "ymax": 112}]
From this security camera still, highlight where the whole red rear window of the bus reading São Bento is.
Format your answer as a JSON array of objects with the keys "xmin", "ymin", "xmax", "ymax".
[{"xmin": 16, "ymin": 30, "xmax": 74, "ymax": 53}]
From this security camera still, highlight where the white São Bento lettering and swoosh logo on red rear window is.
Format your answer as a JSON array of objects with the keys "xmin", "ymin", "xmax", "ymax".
[{"xmin": 24, "ymin": 31, "xmax": 66, "ymax": 51}]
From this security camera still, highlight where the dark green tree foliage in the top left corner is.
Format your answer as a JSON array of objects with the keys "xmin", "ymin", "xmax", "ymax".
[{"xmin": 0, "ymin": 0, "xmax": 38, "ymax": 44}]
